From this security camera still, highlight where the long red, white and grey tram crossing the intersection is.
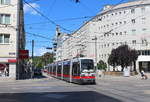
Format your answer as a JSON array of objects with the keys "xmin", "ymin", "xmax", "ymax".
[{"xmin": 46, "ymin": 58, "xmax": 95, "ymax": 84}]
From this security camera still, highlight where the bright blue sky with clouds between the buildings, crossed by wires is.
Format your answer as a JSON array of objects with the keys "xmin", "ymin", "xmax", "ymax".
[{"xmin": 24, "ymin": 0, "xmax": 128, "ymax": 56}]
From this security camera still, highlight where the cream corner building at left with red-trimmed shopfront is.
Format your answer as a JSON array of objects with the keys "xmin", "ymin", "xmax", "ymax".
[{"xmin": 0, "ymin": 0, "xmax": 25, "ymax": 79}]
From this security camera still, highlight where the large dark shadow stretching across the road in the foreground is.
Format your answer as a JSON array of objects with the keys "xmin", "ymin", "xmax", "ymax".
[{"xmin": 0, "ymin": 91, "xmax": 122, "ymax": 102}]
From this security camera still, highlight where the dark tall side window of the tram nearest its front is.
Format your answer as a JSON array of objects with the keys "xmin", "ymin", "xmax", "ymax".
[{"xmin": 72, "ymin": 62, "xmax": 80, "ymax": 76}]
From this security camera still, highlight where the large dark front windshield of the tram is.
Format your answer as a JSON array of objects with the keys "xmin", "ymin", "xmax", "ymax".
[{"xmin": 81, "ymin": 59, "xmax": 94, "ymax": 70}]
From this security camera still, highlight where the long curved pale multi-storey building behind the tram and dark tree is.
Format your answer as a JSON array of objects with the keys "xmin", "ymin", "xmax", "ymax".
[{"xmin": 54, "ymin": 0, "xmax": 150, "ymax": 71}]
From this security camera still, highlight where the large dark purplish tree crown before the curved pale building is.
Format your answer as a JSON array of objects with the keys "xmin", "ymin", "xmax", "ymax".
[{"xmin": 108, "ymin": 45, "xmax": 138, "ymax": 71}]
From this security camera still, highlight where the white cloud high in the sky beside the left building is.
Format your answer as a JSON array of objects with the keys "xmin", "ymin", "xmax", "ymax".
[{"xmin": 23, "ymin": 3, "xmax": 40, "ymax": 15}]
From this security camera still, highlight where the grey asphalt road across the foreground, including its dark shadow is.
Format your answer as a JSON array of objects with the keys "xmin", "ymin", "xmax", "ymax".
[{"xmin": 0, "ymin": 76, "xmax": 150, "ymax": 102}]
